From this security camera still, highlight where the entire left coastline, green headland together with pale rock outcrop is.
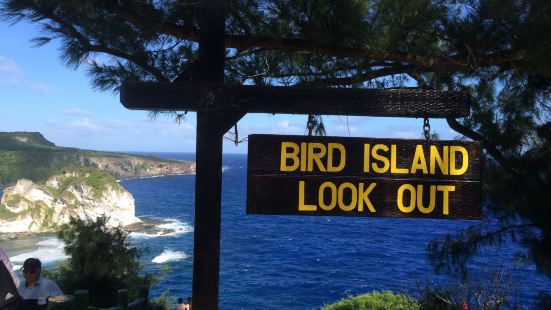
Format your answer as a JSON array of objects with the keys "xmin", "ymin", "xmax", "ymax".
[{"xmin": 0, "ymin": 132, "xmax": 195, "ymax": 233}]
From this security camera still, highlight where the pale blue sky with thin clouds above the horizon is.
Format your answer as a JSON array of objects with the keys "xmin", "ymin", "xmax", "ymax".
[{"xmin": 0, "ymin": 23, "xmax": 456, "ymax": 153}]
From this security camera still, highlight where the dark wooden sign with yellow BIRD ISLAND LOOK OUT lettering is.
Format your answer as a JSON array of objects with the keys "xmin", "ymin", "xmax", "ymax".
[{"xmin": 247, "ymin": 135, "xmax": 482, "ymax": 219}]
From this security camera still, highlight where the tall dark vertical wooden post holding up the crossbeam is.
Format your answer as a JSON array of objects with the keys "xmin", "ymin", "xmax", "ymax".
[{"xmin": 193, "ymin": 0, "xmax": 226, "ymax": 310}]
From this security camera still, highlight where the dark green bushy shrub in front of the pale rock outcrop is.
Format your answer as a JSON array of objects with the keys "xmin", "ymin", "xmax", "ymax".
[{"xmin": 54, "ymin": 217, "xmax": 154, "ymax": 307}]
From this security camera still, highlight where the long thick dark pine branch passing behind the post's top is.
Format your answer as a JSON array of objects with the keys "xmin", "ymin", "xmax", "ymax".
[{"xmin": 92, "ymin": 0, "xmax": 551, "ymax": 76}]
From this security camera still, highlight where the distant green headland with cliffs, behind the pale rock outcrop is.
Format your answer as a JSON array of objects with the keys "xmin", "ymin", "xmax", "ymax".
[{"xmin": 0, "ymin": 132, "xmax": 194, "ymax": 186}]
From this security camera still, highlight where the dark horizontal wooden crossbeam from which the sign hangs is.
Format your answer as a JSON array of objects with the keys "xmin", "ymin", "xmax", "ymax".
[{"xmin": 120, "ymin": 81, "xmax": 470, "ymax": 118}]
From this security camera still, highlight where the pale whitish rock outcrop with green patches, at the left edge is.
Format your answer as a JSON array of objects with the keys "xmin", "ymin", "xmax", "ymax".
[{"xmin": 0, "ymin": 169, "xmax": 140, "ymax": 233}]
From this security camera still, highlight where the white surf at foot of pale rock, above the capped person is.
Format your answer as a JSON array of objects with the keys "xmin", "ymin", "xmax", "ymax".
[{"xmin": 10, "ymin": 238, "xmax": 69, "ymax": 269}]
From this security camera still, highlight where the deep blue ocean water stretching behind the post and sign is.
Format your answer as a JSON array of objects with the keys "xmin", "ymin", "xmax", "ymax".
[{"xmin": 0, "ymin": 153, "xmax": 551, "ymax": 309}]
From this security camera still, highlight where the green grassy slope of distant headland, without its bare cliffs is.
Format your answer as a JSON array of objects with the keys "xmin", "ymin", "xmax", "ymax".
[{"xmin": 0, "ymin": 132, "xmax": 190, "ymax": 186}]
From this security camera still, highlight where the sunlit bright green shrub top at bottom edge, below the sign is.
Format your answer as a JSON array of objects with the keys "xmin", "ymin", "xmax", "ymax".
[{"xmin": 322, "ymin": 291, "xmax": 420, "ymax": 310}]
